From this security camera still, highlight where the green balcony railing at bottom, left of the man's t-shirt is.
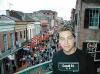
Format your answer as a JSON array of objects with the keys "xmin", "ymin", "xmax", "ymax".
[{"xmin": 14, "ymin": 61, "xmax": 52, "ymax": 74}]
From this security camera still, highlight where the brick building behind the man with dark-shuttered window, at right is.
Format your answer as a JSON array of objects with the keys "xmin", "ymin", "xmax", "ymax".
[{"xmin": 74, "ymin": 0, "xmax": 100, "ymax": 61}]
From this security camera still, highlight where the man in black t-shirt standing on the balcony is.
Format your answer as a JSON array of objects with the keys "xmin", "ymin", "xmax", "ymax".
[{"xmin": 52, "ymin": 27, "xmax": 96, "ymax": 74}]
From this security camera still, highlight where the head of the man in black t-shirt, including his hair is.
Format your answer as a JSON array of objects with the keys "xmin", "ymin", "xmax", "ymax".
[{"xmin": 59, "ymin": 26, "xmax": 75, "ymax": 53}]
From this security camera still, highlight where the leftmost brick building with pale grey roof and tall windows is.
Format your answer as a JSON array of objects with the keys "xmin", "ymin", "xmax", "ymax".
[{"xmin": 0, "ymin": 15, "xmax": 16, "ymax": 74}]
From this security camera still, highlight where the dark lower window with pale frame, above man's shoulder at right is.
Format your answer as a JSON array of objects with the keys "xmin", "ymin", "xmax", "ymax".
[{"xmin": 83, "ymin": 42, "xmax": 100, "ymax": 61}]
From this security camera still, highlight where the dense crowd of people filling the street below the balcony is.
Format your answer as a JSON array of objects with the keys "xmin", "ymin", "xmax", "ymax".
[{"xmin": 16, "ymin": 32, "xmax": 61, "ymax": 70}]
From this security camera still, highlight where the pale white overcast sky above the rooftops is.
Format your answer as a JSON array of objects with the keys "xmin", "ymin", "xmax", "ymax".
[{"xmin": 0, "ymin": 0, "xmax": 76, "ymax": 20}]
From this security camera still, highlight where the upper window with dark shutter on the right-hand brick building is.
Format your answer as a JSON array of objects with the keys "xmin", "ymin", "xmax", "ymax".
[{"xmin": 84, "ymin": 9, "xmax": 100, "ymax": 29}]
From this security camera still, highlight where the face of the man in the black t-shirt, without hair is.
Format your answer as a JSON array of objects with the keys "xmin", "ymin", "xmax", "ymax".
[{"xmin": 59, "ymin": 31, "xmax": 75, "ymax": 52}]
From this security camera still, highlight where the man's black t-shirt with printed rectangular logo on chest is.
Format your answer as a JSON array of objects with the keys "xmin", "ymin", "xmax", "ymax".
[{"xmin": 52, "ymin": 49, "xmax": 96, "ymax": 74}]
